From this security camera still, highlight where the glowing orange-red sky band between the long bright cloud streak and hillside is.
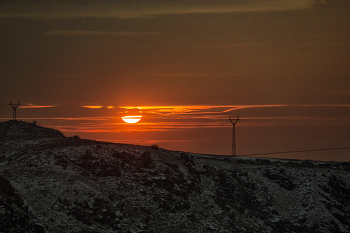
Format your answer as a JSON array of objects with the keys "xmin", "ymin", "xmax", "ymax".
[{"xmin": 3, "ymin": 105, "xmax": 350, "ymax": 161}]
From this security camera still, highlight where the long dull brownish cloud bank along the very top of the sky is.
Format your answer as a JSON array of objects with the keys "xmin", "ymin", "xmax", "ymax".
[{"xmin": 0, "ymin": 0, "xmax": 311, "ymax": 18}]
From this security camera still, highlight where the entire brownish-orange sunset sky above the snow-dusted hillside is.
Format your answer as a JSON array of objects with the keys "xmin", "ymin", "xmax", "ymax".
[{"xmin": 0, "ymin": 0, "xmax": 350, "ymax": 161}]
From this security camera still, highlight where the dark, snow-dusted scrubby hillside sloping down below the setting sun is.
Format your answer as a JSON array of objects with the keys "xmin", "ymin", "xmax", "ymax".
[{"xmin": 0, "ymin": 121, "xmax": 350, "ymax": 233}]
